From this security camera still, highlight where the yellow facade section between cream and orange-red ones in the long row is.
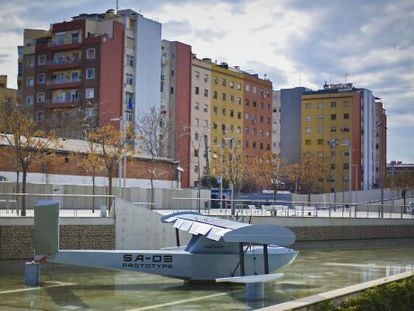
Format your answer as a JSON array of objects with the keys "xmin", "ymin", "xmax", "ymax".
[{"xmin": 210, "ymin": 63, "xmax": 244, "ymax": 176}]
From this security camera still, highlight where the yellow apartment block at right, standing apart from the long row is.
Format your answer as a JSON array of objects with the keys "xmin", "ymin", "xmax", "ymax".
[{"xmin": 301, "ymin": 85, "xmax": 361, "ymax": 192}]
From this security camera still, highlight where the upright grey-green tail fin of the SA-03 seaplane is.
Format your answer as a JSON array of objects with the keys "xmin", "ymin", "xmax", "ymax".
[{"xmin": 34, "ymin": 200, "xmax": 59, "ymax": 260}]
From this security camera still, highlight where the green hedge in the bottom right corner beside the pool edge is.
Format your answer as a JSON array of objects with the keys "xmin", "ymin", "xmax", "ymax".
[{"xmin": 310, "ymin": 277, "xmax": 414, "ymax": 311}]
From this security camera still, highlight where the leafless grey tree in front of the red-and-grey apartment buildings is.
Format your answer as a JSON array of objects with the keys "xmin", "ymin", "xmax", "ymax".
[{"xmin": 135, "ymin": 106, "xmax": 170, "ymax": 208}]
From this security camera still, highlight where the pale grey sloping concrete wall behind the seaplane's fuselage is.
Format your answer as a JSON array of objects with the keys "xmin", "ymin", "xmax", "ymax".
[{"xmin": 115, "ymin": 198, "xmax": 190, "ymax": 250}]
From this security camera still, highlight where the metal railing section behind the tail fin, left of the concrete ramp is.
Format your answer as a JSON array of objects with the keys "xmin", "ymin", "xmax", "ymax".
[{"xmin": 0, "ymin": 193, "xmax": 116, "ymax": 217}]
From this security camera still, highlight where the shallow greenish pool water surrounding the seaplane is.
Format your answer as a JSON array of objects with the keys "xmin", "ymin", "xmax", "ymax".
[{"xmin": 0, "ymin": 245, "xmax": 414, "ymax": 310}]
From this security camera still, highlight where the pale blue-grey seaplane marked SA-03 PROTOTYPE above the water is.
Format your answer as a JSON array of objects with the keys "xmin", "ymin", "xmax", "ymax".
[{"xmin": 34, "ymin": 200, "xmax": 298, "ymax": 283}]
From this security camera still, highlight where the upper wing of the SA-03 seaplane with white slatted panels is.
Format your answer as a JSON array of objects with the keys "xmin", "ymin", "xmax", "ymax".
[{"xmin": 161, "ymin": 212, "xmax": 295, "ymax": 246}]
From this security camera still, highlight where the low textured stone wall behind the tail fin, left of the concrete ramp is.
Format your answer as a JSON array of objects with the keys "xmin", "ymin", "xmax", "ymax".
[{"xmin": 0, "ymin": 218, "xmax": 115, "ymax": 260}]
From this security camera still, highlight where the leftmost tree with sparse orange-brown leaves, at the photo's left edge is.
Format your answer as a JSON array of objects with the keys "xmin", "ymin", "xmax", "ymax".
[{"xmin": 0, "ymin": 107, "xmax": 57, "ymax": 216}]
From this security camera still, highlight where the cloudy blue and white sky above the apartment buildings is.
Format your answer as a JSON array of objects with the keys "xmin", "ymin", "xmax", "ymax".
[{"xmin": 0, "ymin": 0, "xmax": 414, "ymax": 163}]
